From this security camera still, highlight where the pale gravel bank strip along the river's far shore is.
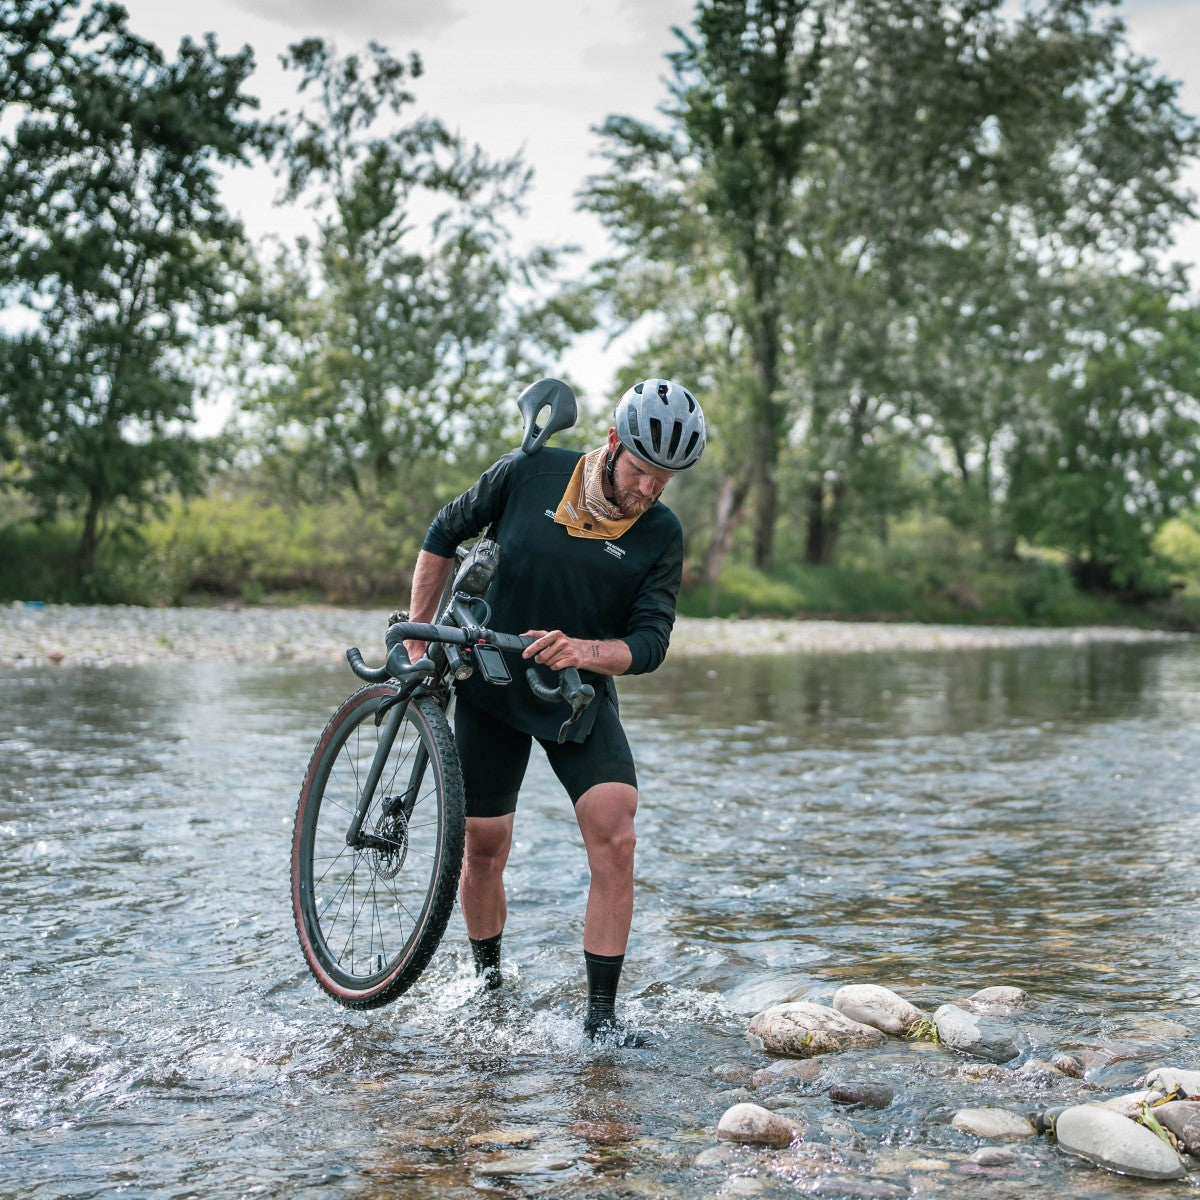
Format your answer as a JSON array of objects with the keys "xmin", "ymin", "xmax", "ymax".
[{"xmin": 0, "ymin": 604, "xmax": 1189, "ymax": 667}]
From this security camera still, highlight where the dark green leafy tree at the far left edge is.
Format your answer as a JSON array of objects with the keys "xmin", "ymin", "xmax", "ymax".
[{"xmin": 0, "ymin": 0, "xmax": 266, "ymax": 575}]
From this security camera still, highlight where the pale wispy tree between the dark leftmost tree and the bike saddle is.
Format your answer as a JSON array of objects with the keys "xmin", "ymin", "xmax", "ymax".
[{"xmin": 256, "ymin": 40, "xmax": 588, "ymax": 501}]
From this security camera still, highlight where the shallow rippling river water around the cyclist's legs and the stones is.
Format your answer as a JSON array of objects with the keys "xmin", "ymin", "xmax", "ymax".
[{"xmin": 0, "ymin": 643, "xmax": 1200, "ymax": 1198}]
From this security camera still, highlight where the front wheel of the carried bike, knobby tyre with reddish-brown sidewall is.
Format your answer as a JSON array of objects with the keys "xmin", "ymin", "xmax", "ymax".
[{"xmin": 292, "ymin": 684, "xmax": 466, "ymax": 1008}]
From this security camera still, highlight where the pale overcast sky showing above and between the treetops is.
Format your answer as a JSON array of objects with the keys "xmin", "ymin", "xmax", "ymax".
[{"xmin": 114, "ymin": 0, "xmax": 1200, "ymax": 408}]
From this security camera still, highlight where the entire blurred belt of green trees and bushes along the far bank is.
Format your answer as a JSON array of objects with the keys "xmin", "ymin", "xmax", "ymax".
[{"xmin": 0, "ymin": 0, "xmax": 1200, "ymax": 625}]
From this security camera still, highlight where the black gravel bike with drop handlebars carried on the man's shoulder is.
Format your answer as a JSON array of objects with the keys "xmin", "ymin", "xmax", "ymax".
[{"xmin": 292, "ymin": 379, "xmax": 593, "ymax": 1008}]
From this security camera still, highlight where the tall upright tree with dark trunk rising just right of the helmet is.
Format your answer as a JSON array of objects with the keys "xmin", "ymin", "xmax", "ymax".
[{"xmin": 583, "ymin": 0, "xmax": 824, "ymax": 571}]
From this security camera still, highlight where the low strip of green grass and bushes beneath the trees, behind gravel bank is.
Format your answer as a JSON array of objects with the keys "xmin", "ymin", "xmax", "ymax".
[{"xmin": 9, "ymin": 494, "xmax": 1200, "ymax": 630}]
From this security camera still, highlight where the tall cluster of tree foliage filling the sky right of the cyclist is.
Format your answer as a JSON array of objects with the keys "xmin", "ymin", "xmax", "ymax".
[{"xmin": 582, "ymin": 0, "xmax": 1198, "ymax": 576}]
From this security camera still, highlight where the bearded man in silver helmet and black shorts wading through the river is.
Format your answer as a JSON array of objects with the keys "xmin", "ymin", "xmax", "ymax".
[{"xmin": 407, "ymin": 379, "xmax": 704, "ymax": 1043}]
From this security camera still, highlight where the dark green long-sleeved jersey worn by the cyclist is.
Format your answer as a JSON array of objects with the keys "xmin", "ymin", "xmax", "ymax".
[{"xmin": 425, "ymin": 446, "xmax": 683, "ymax": 740}]
